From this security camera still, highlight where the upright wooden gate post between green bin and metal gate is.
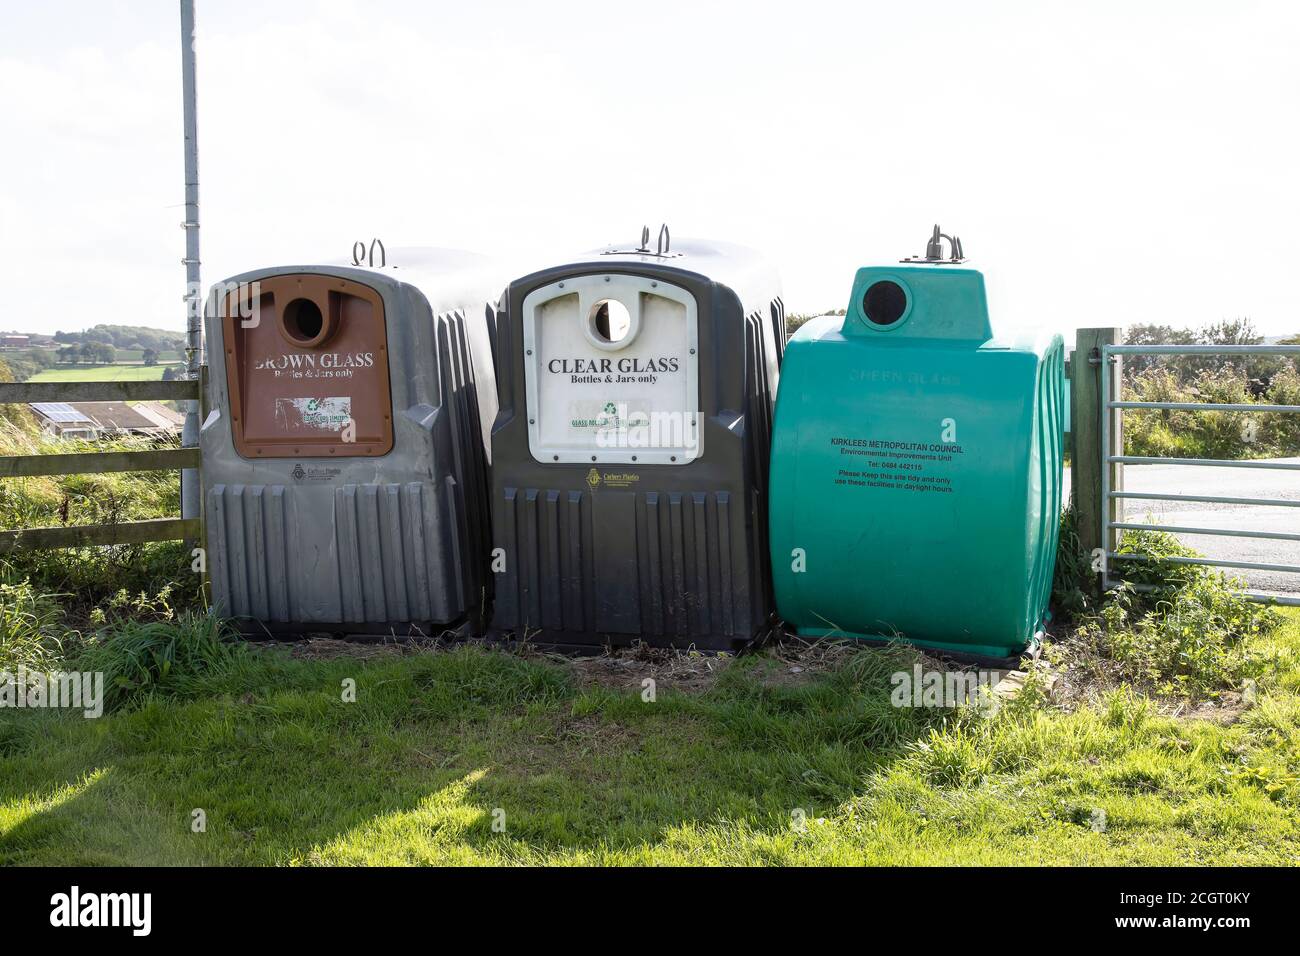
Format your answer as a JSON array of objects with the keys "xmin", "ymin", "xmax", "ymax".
[{"xmin": 1070, "ymin": 328, "xmax": 1125, "ymax": 567}]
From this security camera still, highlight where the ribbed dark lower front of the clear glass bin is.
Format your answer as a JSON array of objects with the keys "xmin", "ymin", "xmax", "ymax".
[{"xmin": 497, "ymin": 488, "xmax": 750, "ymax": 640}]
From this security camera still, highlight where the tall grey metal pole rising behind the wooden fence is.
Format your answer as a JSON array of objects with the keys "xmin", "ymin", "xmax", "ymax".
[{"xmin": 181, "ymin": 0, "xmax": 203, "ymax": 518}]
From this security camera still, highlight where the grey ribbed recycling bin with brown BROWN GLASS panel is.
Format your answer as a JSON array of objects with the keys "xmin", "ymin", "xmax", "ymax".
[{"xmin": 202, "ymin": 251, "xmax": 501, "ymax": 635}]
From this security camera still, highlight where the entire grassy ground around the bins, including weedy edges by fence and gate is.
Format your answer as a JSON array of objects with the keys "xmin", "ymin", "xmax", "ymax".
[{"xmin": 0, "ymin": 494, "xmax": 1300, "ymax": 865}]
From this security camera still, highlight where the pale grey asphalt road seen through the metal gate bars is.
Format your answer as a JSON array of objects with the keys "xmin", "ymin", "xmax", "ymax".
[{"xmin": 1066, "ymin": 458, "xmax": 1300, "ymax": 597}]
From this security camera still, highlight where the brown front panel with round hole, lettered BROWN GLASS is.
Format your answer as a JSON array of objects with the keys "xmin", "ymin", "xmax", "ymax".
[{"xmin": 221, "ymin": 273, "xmax": 393, "ymax": 458}]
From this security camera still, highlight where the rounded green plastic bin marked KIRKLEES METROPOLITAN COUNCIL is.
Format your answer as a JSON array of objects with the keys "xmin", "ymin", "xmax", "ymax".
[{"xmin": 768, "ymin": 265, "xmax": 1065, "ymax": 659}]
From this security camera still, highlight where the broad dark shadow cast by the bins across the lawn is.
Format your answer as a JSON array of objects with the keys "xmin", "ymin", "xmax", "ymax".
[{"xmin": 0, "ymin": 648, "xmax": 936, "ymax": 865}]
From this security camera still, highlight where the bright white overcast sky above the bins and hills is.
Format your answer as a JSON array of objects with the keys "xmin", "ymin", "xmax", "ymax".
[{"xmin": 0, "ymin": 0, "xmax": 1300, "ymax": 334}]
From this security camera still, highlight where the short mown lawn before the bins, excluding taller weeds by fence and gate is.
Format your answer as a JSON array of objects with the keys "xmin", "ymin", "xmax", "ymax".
[{"xmin": 0, "ymin": 611, "xmax": 1300, "ymax": 865}]
